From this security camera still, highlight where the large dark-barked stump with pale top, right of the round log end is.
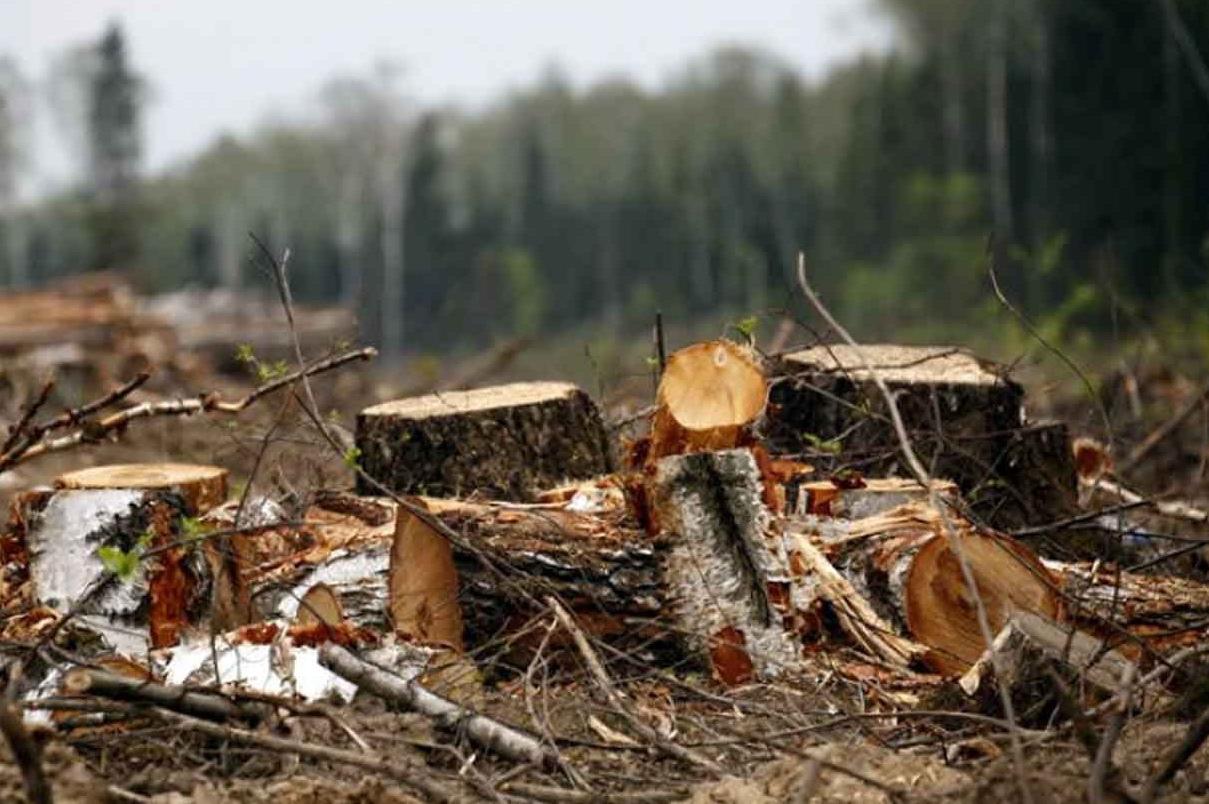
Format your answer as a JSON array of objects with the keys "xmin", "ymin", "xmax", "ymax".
[{"xmin": 768, "ymin": 345, "xmax": 1076, "ymax": 530}]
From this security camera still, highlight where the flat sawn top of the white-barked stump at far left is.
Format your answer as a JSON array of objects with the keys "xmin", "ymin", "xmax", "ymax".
[{"xmin": 54, "ymin": 463, "xmax": 229, "ymax": 516}]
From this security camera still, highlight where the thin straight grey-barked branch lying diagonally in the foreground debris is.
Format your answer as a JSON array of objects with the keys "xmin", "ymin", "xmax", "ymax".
[{"xmin": 319, "ymin": 643, "xmax": 557, "ymax": 768}]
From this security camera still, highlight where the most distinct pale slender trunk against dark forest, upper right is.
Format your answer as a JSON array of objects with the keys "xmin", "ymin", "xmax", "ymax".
[{"xmin": 987, "ymin": 0, "xmax": 1014, "ymax": 254}]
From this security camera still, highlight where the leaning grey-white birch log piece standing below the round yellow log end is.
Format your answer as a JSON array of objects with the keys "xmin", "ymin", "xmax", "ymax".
[{"xmin": 649, "ymin": 450, "xmax": 800, "ymax": 684}]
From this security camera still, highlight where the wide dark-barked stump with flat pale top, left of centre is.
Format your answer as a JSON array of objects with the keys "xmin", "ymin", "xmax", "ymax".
[{"xmin": 357, "ymin": 382, "xmax": 612, "ymax": 501}]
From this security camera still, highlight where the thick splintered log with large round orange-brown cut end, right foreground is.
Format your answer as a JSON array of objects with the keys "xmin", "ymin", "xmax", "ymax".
[{"xmin": 794, "ymin": 503, "xmax": 1062, "ymax": 675}]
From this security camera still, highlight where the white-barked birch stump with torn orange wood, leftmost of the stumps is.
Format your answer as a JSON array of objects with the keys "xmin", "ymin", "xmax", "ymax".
[{"xmin": 24, "ymin": 463, "xmax": 240, "ymax": 653}]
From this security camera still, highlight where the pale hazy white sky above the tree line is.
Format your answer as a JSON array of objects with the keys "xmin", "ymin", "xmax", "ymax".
[{"xmin": 0, "ymin": 0, "xmax": 889, "ymax": 189}]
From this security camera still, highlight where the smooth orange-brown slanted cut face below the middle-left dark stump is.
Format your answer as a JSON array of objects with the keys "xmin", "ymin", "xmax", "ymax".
[{"xmin": 388, "ymin": 503, "xmax": 462, "ymax": 652}]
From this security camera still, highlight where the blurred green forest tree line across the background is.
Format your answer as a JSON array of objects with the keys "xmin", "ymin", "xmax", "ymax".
[{"xmin": 0, "ymin": 0, "xmax": 1209, "ymax": 351}]
